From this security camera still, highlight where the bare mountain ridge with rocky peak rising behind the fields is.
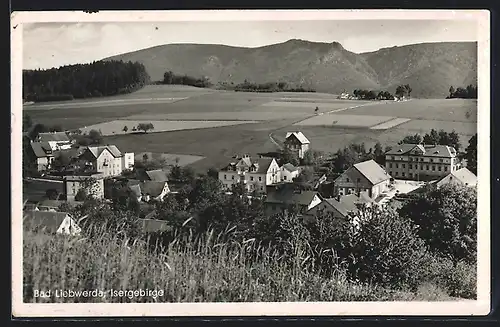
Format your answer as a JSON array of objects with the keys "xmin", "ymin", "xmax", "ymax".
[{"xmin": 104, "ymin": 40, "xmax": 477, "ymax": 98}]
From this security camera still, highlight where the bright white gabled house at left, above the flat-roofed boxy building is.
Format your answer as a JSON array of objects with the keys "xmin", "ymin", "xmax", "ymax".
[{"xmin": 80, "ymin": 145, "xmax": 134, "ymax": 177}]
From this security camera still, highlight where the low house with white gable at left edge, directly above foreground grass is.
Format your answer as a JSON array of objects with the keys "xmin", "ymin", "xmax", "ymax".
[{"xmin": 23, "ymin": 210, "xmax": 81, "ymax": 235}]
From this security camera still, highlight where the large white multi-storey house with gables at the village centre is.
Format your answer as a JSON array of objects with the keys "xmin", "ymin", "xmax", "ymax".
[{"xmin": 219, "ymin": 156, "xmax": 280, "ymax": 193}]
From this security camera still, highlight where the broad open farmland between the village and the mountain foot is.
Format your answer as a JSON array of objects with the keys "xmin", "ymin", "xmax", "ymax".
[{"xmin": 25, "ymin": 86, "xmax": 477, "ymax": 172}]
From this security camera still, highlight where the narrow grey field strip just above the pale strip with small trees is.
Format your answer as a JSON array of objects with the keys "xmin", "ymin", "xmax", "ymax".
[{"xmin": 126, "ymin": 111, "xmax": 312, "ymax": 121}]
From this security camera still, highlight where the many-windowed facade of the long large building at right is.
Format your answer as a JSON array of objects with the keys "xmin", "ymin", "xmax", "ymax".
[{"xmin": 385, "ymin": 155, "xmax": 460, "ymax": 180}]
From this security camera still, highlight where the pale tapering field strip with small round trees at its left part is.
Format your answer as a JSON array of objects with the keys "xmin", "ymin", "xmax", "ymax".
[{"xmin": 80, "ymin": 120, "xmax": 257, "ymax": 136}]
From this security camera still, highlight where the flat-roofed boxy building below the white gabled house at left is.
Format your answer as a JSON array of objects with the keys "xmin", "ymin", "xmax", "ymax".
[{"xmin": 63, "ymin": 173, "xmax": 104, "ymax": 202}]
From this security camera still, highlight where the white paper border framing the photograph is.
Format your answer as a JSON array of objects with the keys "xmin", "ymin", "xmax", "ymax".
[{"xmin": 11, "ymin": 10, "xmax": 491, "ymax": 317}]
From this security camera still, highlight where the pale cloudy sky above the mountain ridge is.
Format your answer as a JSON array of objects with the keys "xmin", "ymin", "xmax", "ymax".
[{"xmin": 23, "ymin": 20, "xmax": 478, "ymax": 69}]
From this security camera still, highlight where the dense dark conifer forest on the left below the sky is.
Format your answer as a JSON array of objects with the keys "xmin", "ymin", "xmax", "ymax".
[{"xmin": 23, "ymin": 60, "xmax": 150, "ymax": 102}]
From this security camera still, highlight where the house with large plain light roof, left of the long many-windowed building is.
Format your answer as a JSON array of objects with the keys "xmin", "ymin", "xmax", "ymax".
[{"xmin": 334, "ymin": 160, "xmax": 391, "ymax": 199}]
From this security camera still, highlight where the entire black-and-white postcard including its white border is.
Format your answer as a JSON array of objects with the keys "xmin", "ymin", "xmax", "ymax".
[{"xmin": 11, "ymin": 10, "xmax": 490, "ymax": 316}]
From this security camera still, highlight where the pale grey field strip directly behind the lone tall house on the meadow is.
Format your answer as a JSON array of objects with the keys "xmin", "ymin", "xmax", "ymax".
[{"xmin": 294, "ymin": 114, "xmax": 394, "ymax": 128}]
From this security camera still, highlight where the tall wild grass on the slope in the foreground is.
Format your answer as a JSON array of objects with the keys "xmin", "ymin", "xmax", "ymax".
[{"xmin": 23, "ymin": 227, "xmax": 462, "ymax": 302}]
